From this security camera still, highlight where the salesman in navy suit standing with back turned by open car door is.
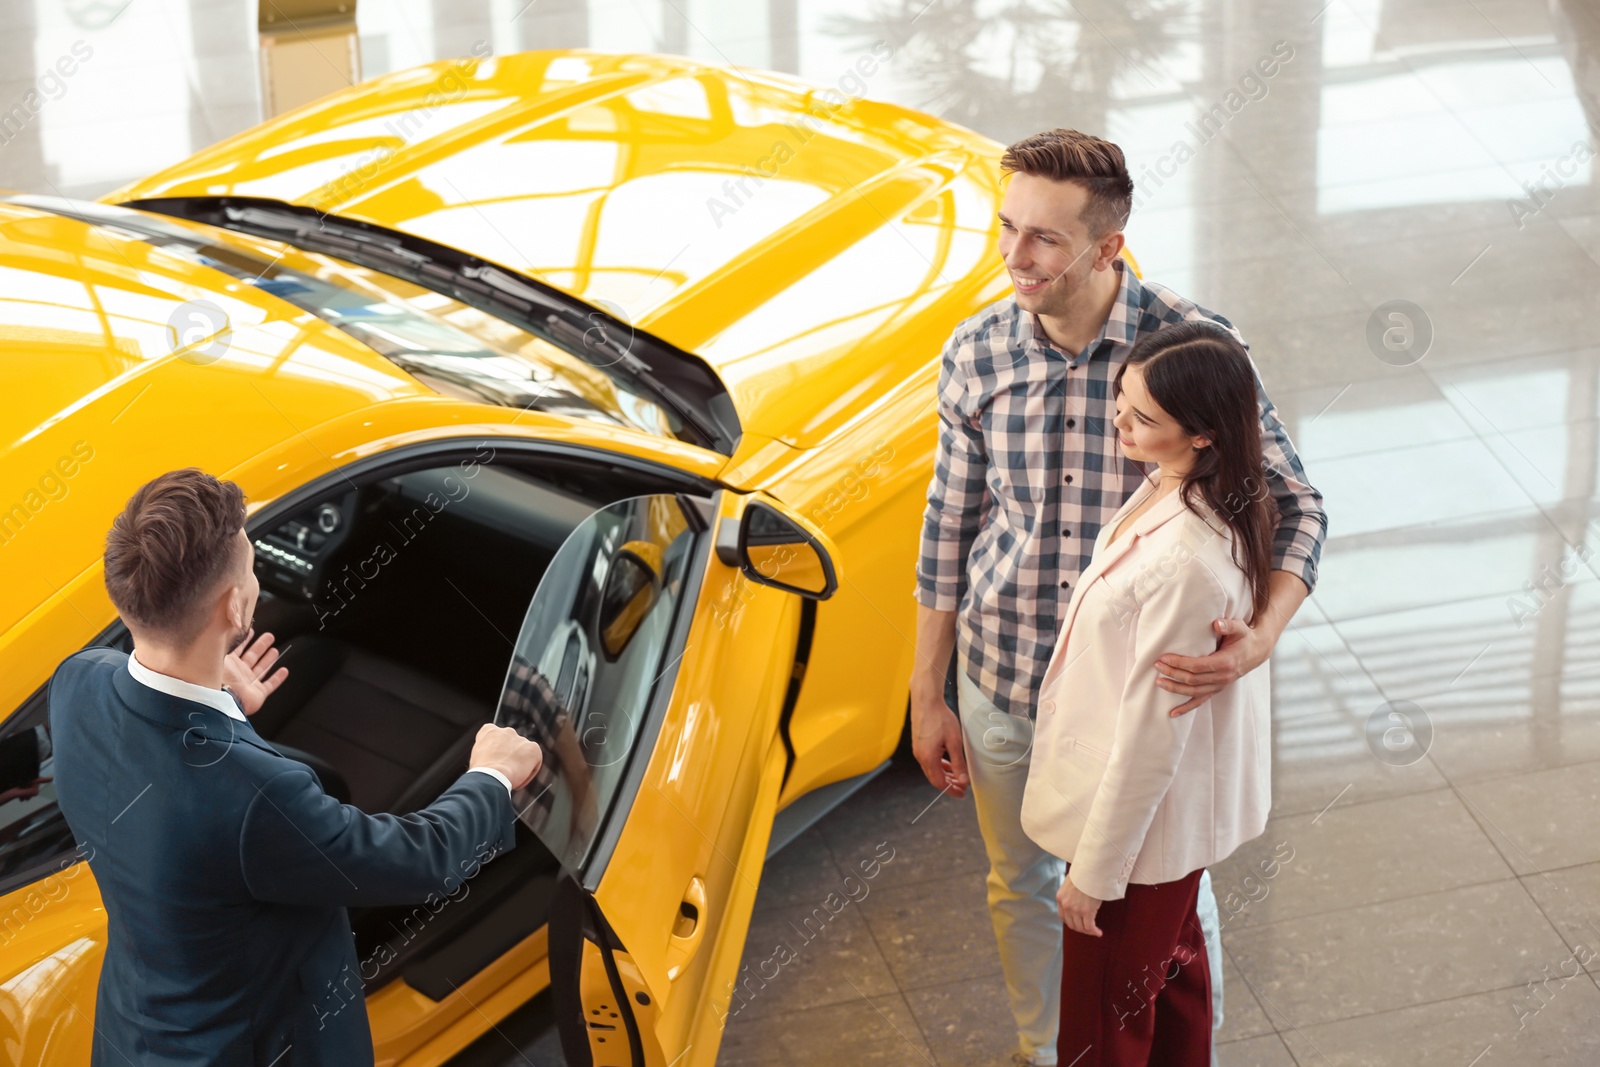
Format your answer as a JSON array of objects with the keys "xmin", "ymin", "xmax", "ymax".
[{"xmin": 50, "ymin": 467, "xmax": 542, "ymax": 1067}]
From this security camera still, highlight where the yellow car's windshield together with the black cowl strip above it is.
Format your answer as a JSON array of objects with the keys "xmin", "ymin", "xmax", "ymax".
[{"xmin": 25, "ymin": 195, "xmax": 739, "ymax": 454}]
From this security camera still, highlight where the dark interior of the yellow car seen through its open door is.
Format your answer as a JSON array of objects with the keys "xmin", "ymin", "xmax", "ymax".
[{"xmin": 0, "ymin": 454, "xmax": 713, "ymax": 1000}]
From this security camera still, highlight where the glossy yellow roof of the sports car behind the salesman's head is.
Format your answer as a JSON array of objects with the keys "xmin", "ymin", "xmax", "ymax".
[{"xmin": 0, "ymin": 202, "xmax": 435, "ymax": 643}]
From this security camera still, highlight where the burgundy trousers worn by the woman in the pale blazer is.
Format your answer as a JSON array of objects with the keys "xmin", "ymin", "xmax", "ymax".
[{"xmin": 1056, "ymin": 864, "xmax": 1211, "ymax": 1067}]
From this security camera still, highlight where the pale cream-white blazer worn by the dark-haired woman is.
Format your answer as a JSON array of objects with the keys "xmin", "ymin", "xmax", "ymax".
[{"xmin": 1022, "ymin": 482, "xmax": 1272, "ymax": 901}]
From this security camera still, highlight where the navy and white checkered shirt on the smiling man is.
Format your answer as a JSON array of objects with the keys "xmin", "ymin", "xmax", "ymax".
[{"xmin": 915, "ymin": 259, "xmax": 1328, "ymax": 718}]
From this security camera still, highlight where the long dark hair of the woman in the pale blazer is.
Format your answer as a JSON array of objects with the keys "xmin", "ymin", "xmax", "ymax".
[{"xmin": 1114, "ymin": 320, "xmax": 1278, "ymax": 619}]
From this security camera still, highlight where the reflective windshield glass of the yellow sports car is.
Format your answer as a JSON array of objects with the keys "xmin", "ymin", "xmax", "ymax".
[{"xmin": 10, "ymin": 197, "xmax": 732, "ymax": 446}]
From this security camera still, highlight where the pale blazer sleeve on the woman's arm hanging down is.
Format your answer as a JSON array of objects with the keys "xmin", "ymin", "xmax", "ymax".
[{"xmin": 1069, "ymin": 558, "xmax": 1227, "ymax": 901}]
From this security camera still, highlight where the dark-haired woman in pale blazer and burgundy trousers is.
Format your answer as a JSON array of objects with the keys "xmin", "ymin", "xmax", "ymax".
[{"xmin": 1022, "ymin": 322, "xmax": 1277, "ymax": 1067}]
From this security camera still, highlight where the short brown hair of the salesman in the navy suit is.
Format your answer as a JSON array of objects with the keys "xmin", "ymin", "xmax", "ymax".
[{"xmin": 106, "ymin": 467, "xmax": 245, "ymax": 640}]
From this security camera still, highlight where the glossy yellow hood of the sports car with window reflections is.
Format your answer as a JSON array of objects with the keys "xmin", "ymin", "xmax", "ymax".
[{"xmin": 106, "ymin": 51, "xmax": 1006, "ymax": 448}]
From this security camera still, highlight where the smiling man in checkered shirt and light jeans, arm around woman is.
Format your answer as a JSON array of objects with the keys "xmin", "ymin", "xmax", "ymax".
[{"xmin": 910, "ymin": 130, "xmax": 1326, "ymax": 1067}]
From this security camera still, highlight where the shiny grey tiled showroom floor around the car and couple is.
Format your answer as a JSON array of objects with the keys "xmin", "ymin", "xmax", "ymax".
[{"xmin": 12, "ymin": 0, "xmax": 1600, "ymax": 1067}]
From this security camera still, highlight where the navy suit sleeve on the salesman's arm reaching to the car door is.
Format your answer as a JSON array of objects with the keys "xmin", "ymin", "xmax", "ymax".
[{"xmin": 238, "ymin": 766, "xmax": 515, "ymax": 907}]
